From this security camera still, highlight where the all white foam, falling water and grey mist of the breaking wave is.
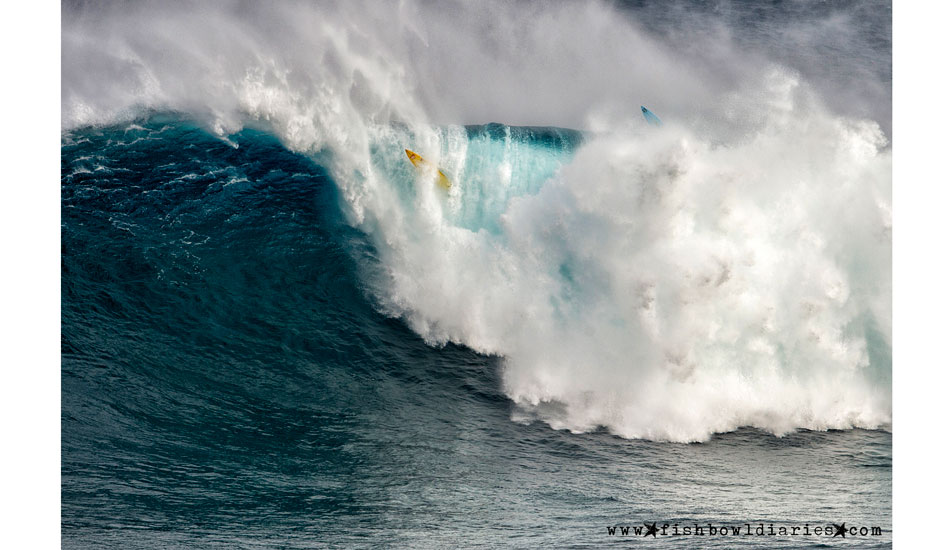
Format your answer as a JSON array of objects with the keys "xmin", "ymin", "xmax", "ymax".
[{"xmin": 62, "ymin": 1, "xmax": 892, "ymax": 442}]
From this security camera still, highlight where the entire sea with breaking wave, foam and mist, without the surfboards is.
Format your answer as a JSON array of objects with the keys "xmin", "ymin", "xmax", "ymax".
[{"xmin": 61, "ymin": 2, "xmax": 892, "ymax": 549}]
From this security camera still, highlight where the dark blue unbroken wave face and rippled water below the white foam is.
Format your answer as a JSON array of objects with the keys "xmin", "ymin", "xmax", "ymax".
[{"xmin": 61, "ymin": 119, "xmax": 891, "ymax": 548}]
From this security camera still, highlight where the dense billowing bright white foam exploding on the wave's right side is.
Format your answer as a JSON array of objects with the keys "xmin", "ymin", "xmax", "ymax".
[{"xmin": 358, "ymin": 74, "xmax": 890, "ymax": 441}]
